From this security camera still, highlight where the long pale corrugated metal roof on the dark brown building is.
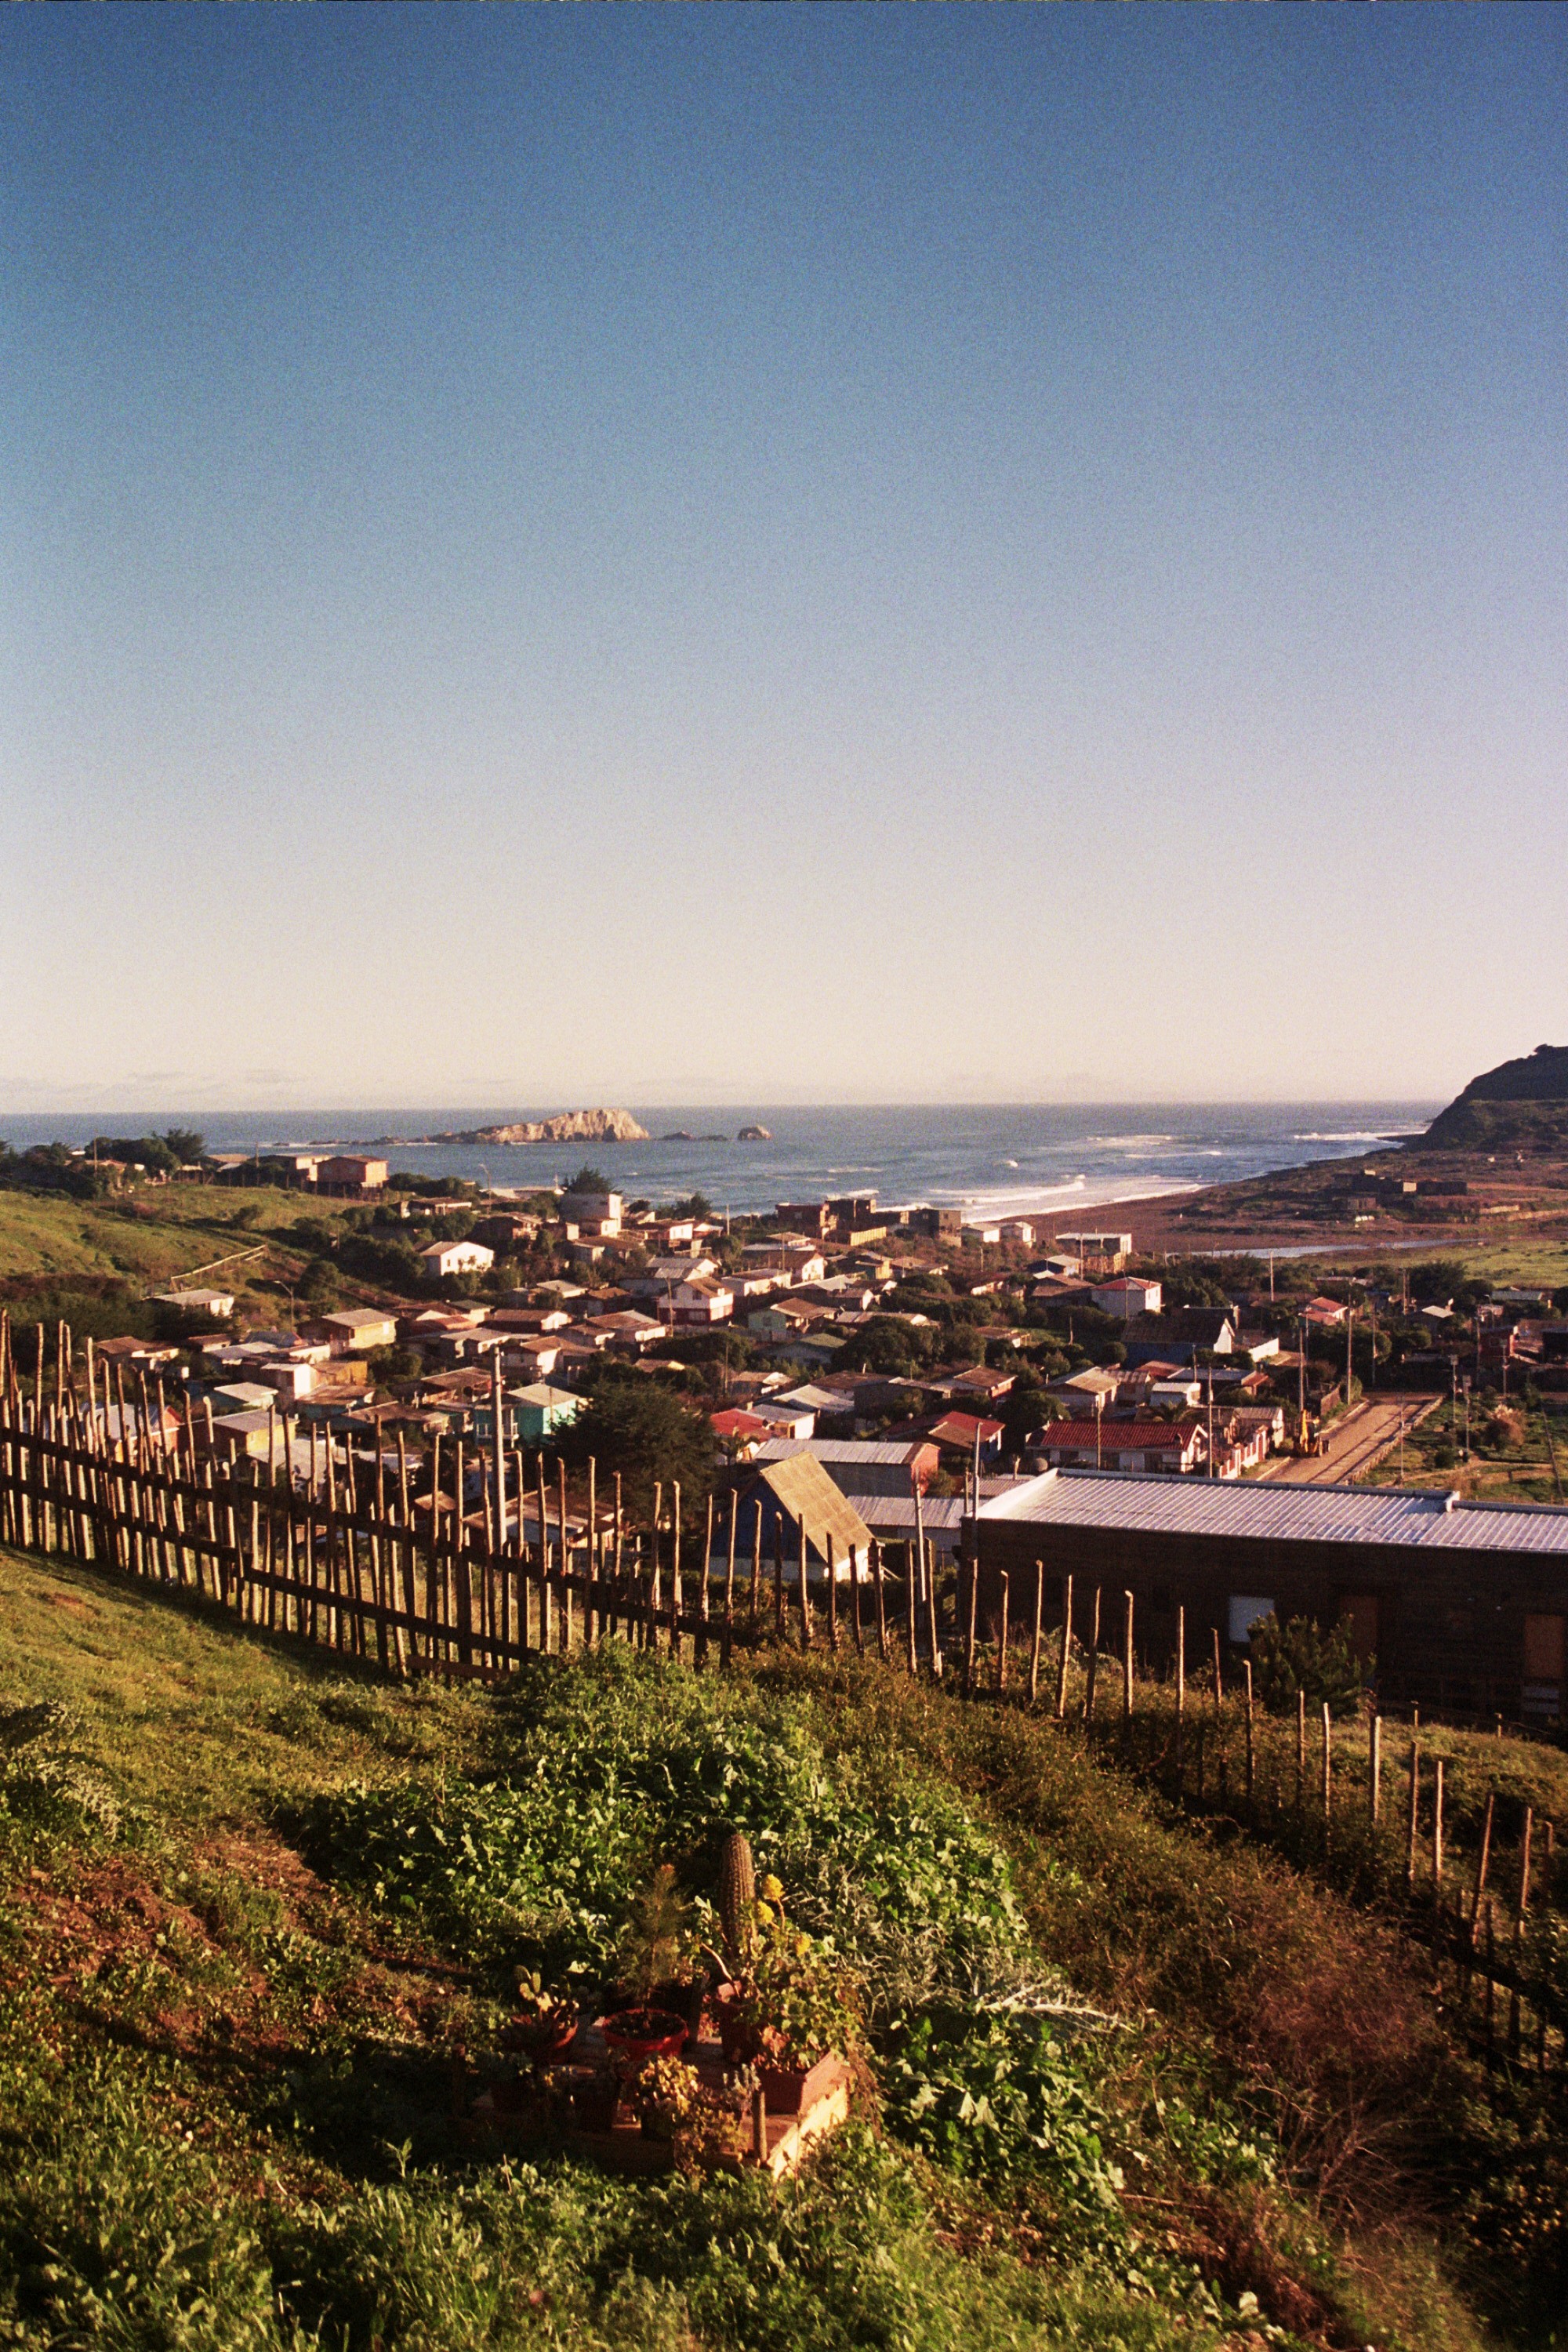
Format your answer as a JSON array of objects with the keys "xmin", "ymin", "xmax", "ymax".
[{"xmin": 980, "ymin": 1470, "xmax": 1568, "ymax": 1555}]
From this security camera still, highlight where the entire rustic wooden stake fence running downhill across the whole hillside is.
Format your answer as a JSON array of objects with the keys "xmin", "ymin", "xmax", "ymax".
[{"xmin": 0, "ymin": 1317, "xmax": 1568, "ymax": 2074}]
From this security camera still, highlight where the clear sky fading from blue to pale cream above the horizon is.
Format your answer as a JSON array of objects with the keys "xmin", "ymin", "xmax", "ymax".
[{"xmin": 0, "ymin": 5, "xmax": 1568, "ymax": 1112}]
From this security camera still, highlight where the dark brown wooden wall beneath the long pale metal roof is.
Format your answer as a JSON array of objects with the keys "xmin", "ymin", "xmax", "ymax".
[{"xmin": 978, "ymin": 1519, "xmax": 1568, "ymax": 1722}]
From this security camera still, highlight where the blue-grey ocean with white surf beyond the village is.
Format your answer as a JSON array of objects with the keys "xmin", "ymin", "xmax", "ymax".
[{"xmin": 0, "ymin": 1103, "xmax": 1441, "ymax": 1221}]
